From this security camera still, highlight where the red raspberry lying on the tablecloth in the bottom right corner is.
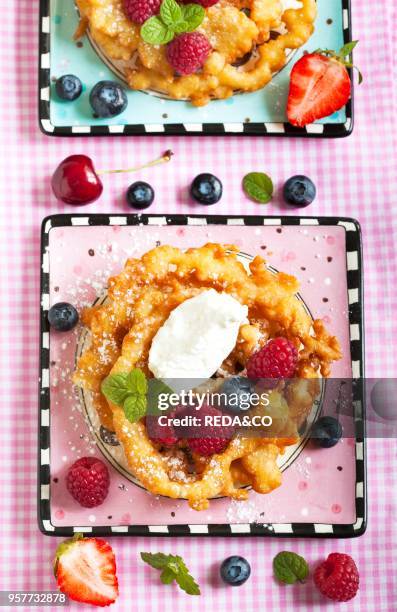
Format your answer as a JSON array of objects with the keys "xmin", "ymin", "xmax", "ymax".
[{"xmin": 314, "ymin": 553, "xmax": 359, "ymax": 601}]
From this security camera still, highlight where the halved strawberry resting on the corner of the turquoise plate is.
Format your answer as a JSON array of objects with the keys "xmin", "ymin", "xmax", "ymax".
[{"xmin": 287, "ymin": 41, "xmax": 362, "ymax": 127}]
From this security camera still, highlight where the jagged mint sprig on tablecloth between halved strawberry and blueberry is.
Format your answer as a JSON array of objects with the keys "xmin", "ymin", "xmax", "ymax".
[{"xmin": 141, "ymin": 552, "xmax": 200, "ymax": 595}]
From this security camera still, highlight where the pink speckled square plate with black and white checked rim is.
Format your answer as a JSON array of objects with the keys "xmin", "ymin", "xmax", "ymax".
[{"xmin": 38, "ymin": 215, "xmax": 366, "ymax": 537}]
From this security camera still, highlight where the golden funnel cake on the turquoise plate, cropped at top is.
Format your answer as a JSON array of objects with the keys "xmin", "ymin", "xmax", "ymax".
[{"xmin": 76, "ymin": 0, "xmax": 317, "ymax": 106}]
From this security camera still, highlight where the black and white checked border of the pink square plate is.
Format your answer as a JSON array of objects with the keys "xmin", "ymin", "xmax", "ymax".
[{"xmin": 38, "ymin": 214, "xmax": 366, "ymax": 538}]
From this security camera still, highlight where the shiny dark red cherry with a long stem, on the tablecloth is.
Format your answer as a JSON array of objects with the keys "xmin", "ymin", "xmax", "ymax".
[{"xmin": 51, "ymin": 155, "xmax": 103, "ymax": 206}]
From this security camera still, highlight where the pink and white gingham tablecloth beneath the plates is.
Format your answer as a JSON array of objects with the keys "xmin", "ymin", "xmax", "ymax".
[{"xmin": 0, "ymin": 0, "xmax": 397, "ymax": 612}]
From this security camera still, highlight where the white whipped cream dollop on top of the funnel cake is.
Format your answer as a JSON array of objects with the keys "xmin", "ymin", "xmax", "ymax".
[{"xmin": 149, "ymin": 289, "xmax": 248, "ymax": 379}]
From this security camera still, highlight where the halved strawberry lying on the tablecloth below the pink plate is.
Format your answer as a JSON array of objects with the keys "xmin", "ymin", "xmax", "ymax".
[{"xmin": 54, "ymin": 533, "xmax": 119, "ymax": 606}]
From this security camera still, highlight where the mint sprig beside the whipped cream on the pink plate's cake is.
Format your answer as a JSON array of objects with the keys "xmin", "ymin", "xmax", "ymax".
[{"xmin": 101, "ymin": 368, "xmax": 148, "ymax": 423}]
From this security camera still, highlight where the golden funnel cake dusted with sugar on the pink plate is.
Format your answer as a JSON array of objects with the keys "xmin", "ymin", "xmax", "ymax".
[{"xmin": 74, "ymin": 244, "xmax": 341, "ymax": 510}]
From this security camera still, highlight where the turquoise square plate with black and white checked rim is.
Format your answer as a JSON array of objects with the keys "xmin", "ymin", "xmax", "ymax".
[{"xmin": 39, "ymin": 0, "xmax": 353, "ymax": 138}]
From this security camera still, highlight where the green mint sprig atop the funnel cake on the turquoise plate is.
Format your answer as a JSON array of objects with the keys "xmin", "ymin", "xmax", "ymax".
[{"xmin": 141, "ymin": 0, "xmax": 205, "ymax": 45}]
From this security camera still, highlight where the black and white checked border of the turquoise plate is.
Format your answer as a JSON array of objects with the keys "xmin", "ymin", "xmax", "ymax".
[{"xmin": 39, "ymin": 0, "xmax": 353, "ymax": 138}]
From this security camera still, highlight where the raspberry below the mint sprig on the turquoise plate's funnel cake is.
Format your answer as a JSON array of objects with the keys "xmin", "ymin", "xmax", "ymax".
[{"xmin": 167, "ymin": 32, "xmax": 211, "ymax": 75}]
